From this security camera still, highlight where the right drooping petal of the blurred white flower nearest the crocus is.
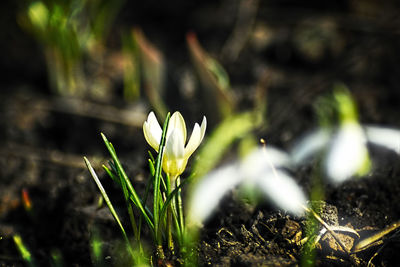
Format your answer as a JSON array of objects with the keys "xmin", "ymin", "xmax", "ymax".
[{"xmin": 257, "ymin": 170, "xmax": 307, "ymax": 216}]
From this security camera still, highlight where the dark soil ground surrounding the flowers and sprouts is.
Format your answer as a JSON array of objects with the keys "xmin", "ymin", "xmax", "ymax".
[{"xmin": 0, "ymin": 0, "xmax": 400, "ymax": 266}]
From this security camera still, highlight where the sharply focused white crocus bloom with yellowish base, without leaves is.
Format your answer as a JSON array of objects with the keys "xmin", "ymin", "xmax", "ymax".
[{"xmin": 143, "ymin": 111, "xmax": 207, "ymax": 179}]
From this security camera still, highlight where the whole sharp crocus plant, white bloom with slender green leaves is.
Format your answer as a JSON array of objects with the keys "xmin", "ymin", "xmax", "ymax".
[{"xmin": 84, "ymin": 112, "xmax": 207, "ymax": 264}]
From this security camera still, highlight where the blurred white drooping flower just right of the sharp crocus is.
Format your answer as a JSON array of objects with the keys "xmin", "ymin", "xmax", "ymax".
[{"xmin": 188, "ymin": 147, "xmax": 307, "ymax": 224}]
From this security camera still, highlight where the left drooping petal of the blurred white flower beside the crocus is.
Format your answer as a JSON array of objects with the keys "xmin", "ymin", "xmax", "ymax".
[{"xmin": 188, "ymin": 165, "xmax": 242, "ymax": 225}]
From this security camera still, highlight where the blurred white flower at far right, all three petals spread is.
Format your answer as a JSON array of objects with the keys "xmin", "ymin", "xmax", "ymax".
[{"xmin": 290, "ymin": 125, "xmax": 400, "ymax": 183}]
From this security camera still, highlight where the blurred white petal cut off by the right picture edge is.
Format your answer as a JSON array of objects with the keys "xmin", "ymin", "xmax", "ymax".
[{"xmin": 365, "ymin": 126, "xmax": 400, "ymax": 154}]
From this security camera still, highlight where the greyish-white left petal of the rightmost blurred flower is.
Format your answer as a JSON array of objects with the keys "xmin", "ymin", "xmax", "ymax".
[{"xmin": 290, "ymin": 129, "xmax": 330, "ymax": 165}]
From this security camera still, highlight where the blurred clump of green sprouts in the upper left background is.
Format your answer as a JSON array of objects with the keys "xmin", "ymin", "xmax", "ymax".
[{"xmin": 18, "ymin": 0, "xmax": 123, "ymax": 96}]
